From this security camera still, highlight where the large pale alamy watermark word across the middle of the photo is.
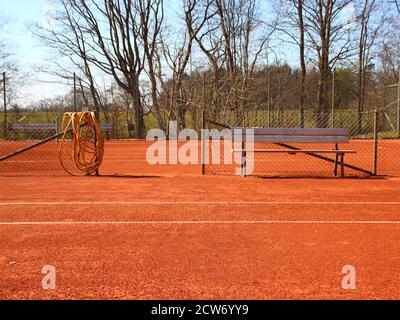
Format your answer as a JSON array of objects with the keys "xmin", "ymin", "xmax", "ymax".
[{"xmin": 146, "ymin": 121, "xmax": 254, "ymax": 175}]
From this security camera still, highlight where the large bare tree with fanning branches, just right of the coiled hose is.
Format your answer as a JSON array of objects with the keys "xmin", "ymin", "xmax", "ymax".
[{"xmin": 39, "ymin": 0, "xmax": 163, "ymax": 138}]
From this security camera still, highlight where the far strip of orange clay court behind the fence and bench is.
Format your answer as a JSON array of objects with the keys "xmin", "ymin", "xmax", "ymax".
[{"xmin": 0, "ymin": 140, "xmax": 400, "ymax": 178}]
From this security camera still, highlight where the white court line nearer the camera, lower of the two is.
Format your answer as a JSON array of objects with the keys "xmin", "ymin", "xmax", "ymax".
[{"xmin": 0, "ymin": 220, "xmax": 400, "ymax": 226}]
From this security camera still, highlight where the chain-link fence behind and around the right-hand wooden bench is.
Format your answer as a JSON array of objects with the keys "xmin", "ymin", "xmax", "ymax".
[{"xmin": 206, "ymin": 110, "xmax": 400, "ymax": 176}]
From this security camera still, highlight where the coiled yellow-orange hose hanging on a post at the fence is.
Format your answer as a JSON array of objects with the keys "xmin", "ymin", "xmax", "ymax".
[{"xmin": 59, "ymin": 112, "xmax": 104, "ymax": 176}]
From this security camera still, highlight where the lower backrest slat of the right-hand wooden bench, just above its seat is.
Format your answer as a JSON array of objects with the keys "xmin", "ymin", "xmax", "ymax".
[{"xmin": 233, "ymin": 135, "xmax": 350, "ymax": 143}]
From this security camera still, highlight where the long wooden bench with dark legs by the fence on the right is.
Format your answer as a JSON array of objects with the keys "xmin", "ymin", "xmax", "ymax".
[{"xmin": 232, "ymin": 128, "xmax": 356, "ymax": 177}]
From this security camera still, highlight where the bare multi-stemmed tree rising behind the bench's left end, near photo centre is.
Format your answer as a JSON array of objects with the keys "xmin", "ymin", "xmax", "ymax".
[{"xmin": 188, "ymin": 0, "xmax": 275, "ymax": 120}]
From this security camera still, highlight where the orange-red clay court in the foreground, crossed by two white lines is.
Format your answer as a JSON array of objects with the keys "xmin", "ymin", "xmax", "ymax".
[{"xmin": 0, "ymin": 142, "xmax": 400, "ymax": 299}]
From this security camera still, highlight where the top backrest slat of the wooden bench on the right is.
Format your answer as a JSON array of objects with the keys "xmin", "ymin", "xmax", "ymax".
[{"xmin": 233, "ymin": 128, "xmax": 349, "ymax": 136}]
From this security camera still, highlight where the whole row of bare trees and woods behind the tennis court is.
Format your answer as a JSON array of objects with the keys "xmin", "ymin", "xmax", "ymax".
[{"xmin": 0, "ymin": 0, "xmax": 400, "ymax": 138}]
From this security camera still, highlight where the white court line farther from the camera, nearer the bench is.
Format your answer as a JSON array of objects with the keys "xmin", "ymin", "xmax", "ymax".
[{"xmin": 0, "ymin": 201, "xmax": 400, "ymax": 207}]
